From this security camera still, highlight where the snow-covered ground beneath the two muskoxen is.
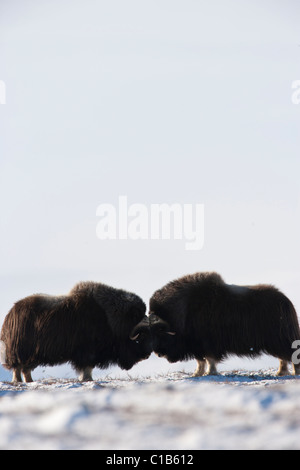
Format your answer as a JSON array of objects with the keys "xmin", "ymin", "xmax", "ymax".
[{"xmin": 0, "ymin": 369, "xmax": 300, "ymax": 450}]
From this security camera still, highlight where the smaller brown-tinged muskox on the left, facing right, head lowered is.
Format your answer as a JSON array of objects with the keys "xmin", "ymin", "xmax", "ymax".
[{"xmin": 0, "ymin": 282, "xmax": 152, "ymax": 382}]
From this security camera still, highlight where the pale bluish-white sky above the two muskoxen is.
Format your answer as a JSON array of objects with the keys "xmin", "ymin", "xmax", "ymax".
[{"xmin": 0, "ymin": 0, "xmax": 300, "ymax": 378}]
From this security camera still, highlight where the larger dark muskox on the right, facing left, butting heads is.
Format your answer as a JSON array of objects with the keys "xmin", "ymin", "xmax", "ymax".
[{"xmin": 149, "ymin": 273, "xmax": 300, "ymax": 376}]
